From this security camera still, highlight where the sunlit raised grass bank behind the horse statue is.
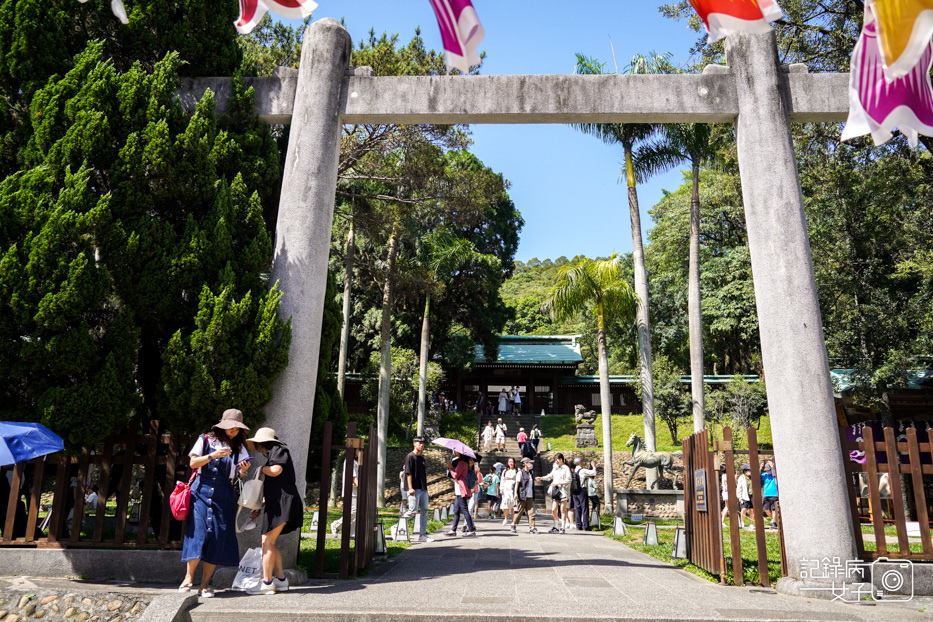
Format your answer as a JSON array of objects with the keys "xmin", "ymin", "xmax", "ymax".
[{"xmin": 541, "ymin": 415, "xmax": 773, "ymax": 451}]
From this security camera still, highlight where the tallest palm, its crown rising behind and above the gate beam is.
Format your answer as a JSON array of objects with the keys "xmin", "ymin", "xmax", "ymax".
[{"xmin": 574, "ymin": 52, "xmax": 674, "ymax": 472}]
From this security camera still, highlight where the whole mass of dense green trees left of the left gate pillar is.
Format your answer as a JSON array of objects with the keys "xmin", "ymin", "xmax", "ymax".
[{"xmin": 0, "ymin": 0, "xmax": 290, "ymax": 446}]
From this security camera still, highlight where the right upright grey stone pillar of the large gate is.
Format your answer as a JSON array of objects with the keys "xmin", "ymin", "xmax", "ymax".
[{"xmin": 726, "ymin": 33, "xmax": 856, "ymax": 596}]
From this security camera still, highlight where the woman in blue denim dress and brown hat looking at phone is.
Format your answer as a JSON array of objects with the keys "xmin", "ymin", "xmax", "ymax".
[{"xmin": 178, "ymin": 408, "xmax": 250, "ymax": 598}]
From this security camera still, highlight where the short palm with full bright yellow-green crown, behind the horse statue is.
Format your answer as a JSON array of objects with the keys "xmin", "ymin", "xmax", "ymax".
[{"xmin": 541, "ymin": 253, "xmax": 637, "ymax": 503}]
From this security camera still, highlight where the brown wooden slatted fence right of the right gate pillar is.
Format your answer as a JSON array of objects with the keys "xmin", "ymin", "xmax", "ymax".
[{"xmin": 840, "ymin": 426, "xmax": 933, "ymax": 561}]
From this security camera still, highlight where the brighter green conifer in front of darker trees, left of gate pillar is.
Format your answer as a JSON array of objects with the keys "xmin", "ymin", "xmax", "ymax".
[{"xmin": 2, "ymin": 43, "xmax": 289, "ymax": 442}]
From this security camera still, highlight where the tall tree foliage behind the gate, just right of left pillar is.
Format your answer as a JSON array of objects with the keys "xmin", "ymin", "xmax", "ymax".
[{"xmin": 331, "ymin": 31, "xmax": 523, "ymax": 404}]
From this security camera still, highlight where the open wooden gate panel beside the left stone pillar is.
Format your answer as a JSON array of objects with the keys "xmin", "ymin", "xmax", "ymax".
[{"xmin": 311, "ymin": 421, "xmax": 376, "ymax": 579}]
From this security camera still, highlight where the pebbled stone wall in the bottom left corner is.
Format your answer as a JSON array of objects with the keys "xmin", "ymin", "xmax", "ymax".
[{"xmin": 0, "ymin": 586, "xmax": 153, "ymax": 622}]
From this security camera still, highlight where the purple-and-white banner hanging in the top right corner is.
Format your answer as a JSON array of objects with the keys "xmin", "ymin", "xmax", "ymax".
[{"xmin": 841, "ymin": 5, "xmax": 933, "ymax": 148}]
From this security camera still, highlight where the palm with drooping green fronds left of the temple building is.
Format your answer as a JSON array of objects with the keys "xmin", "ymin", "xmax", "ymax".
[{"xmin": 418, "ymin": 228, "xmax": 501, "ymax": 436}]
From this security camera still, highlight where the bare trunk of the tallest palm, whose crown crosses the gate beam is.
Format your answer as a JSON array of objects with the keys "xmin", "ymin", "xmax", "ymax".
[{"xmin": 625, "ymin": 145, "xmax": 658, "ymax": 485}]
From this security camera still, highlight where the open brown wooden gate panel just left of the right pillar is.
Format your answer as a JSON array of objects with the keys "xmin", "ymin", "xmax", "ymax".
[{"xmin": 683, "ymin": 427, "xmax": 787, "ymax": 587}]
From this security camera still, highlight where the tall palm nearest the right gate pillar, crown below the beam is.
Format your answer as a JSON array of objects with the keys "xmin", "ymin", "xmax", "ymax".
[{"xmin": 637, "ymin": 123, "xmax": 716, "ymax": 432}]
